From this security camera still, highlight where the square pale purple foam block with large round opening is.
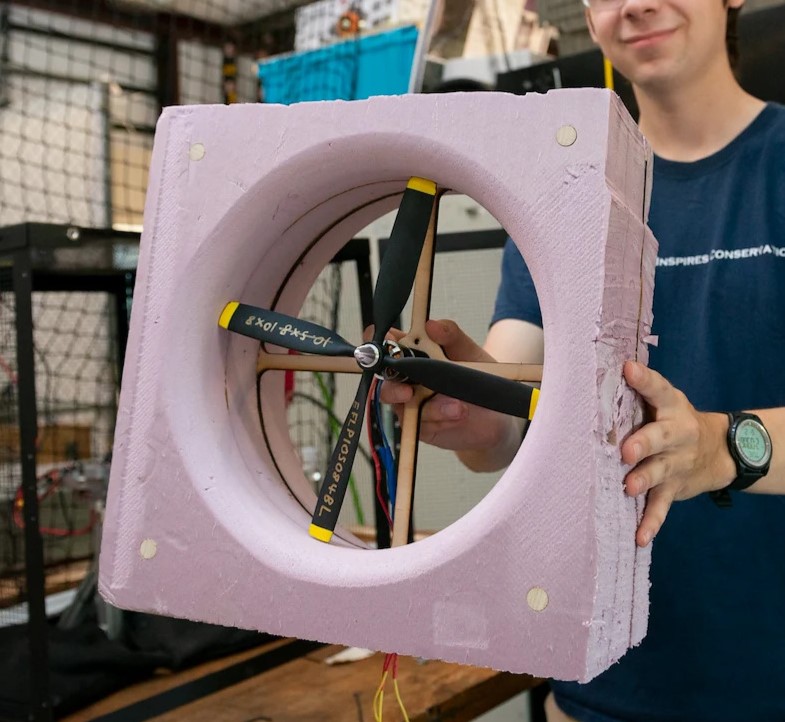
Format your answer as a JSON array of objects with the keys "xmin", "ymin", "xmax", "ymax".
[{"xmin": 100, "ymin": 90, "xmax": 656, "ymax": 680}]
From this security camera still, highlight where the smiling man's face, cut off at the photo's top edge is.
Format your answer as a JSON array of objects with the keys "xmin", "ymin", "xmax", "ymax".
[{"xmin": 586, "ymin": 0, "xmax": 744, "ymax": 90}]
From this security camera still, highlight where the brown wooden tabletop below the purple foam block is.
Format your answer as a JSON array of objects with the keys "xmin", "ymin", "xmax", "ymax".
[{"xmin": 65, "ymin": 640, "xmax": 540, "ymax": 722}]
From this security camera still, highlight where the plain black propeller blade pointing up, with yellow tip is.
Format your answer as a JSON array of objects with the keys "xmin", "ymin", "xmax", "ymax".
[{"xmin": 373, "ymin": 178, "xmax": 436, "ymax": 345}]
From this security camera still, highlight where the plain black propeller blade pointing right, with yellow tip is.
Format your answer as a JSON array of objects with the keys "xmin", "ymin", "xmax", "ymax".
[{"xmin": 383, "ymin": 356, "xmax": 540, "ymax": 419}]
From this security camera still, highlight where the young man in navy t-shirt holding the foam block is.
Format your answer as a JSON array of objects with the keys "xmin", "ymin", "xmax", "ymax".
[{"xmin": 385, "ymin": 0, "xmax": 785, "ymax": 722}]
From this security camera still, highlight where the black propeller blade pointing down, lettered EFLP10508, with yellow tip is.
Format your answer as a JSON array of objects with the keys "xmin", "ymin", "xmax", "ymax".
[{"xmin": 308, "ymin": 371, "xmax": 373, "ymax": 542}]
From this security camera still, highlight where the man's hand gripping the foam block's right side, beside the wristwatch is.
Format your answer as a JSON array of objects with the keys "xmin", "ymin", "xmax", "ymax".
[{"xmin": 621, "ymin": 361, "xmax": 736, "ymax": 546}]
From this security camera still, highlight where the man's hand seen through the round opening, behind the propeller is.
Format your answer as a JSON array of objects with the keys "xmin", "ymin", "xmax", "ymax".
[{"xmin": 382, "ymin": 320, "xmax": 522, "ymax": 471}]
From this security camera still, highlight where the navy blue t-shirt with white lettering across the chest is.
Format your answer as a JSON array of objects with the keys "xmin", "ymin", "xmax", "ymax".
[{"xmin": 494, "ymin": 104, "xmax": 785, "ymax": 722}]
